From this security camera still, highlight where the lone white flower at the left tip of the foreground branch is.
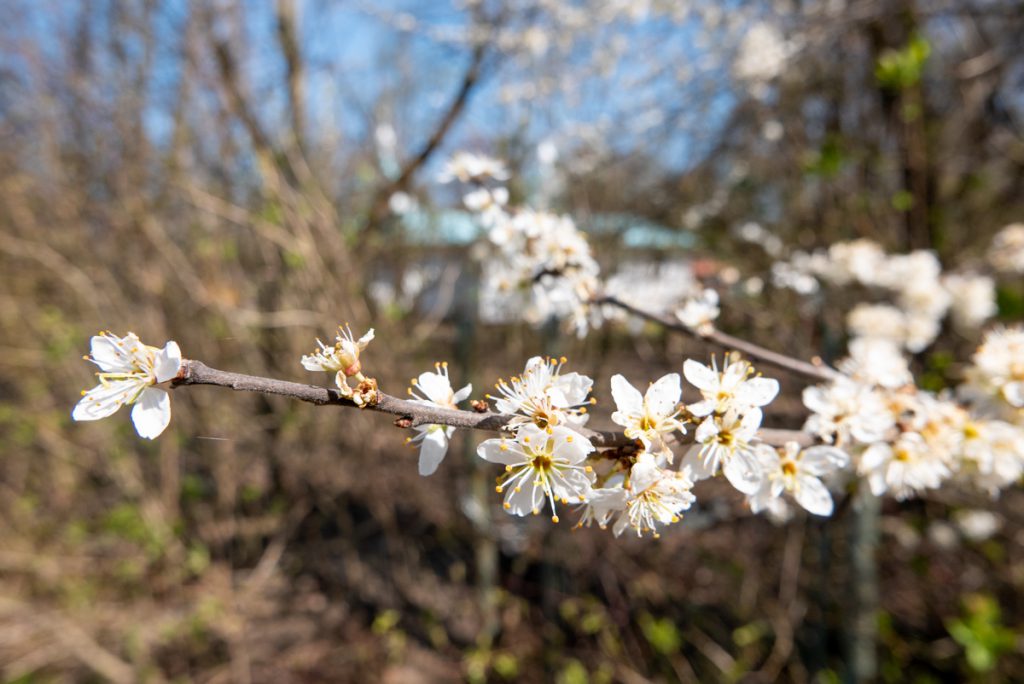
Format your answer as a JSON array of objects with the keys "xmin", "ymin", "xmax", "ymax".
[{"xmin": 71, "ymin": 332, "xmax": 181, "ymax": 439}]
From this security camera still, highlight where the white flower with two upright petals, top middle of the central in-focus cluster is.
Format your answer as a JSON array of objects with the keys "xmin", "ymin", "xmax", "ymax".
[{"xmin": 611, "ymin": 373, "xmax": 686, "ymax": 463}]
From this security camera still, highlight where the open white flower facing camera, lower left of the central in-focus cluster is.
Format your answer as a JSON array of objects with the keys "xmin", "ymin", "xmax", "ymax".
[{"xmin": 476, "ymin": 424, "xmax": 595, "ymax": 522}]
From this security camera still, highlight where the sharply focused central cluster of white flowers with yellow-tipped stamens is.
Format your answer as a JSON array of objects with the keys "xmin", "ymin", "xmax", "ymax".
[{"xmin": 466, "ymin": 356, "xmax": 847, "ymax": 536}]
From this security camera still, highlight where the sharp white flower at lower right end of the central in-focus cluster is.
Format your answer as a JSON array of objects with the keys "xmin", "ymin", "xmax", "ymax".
[{"xmin": 748, "ymin": 441, "xmax": 850, "ymax": 516}]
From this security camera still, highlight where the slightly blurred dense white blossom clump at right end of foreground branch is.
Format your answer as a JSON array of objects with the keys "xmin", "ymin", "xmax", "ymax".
[{"xmin": 804, "ymin": 330, "xmax": 1024, "ymax": 499}]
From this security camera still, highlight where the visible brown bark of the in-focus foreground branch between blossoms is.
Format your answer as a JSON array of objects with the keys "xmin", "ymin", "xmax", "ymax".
[{"xmin": 172, "ymin": 359, "xmax": 812, "ymax": 447}]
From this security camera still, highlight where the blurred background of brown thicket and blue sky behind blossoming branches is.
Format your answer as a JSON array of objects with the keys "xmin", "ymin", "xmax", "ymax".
[{"xmin": 0, "ymin": 0, "xmax": 1024, "ymax": 683}]
